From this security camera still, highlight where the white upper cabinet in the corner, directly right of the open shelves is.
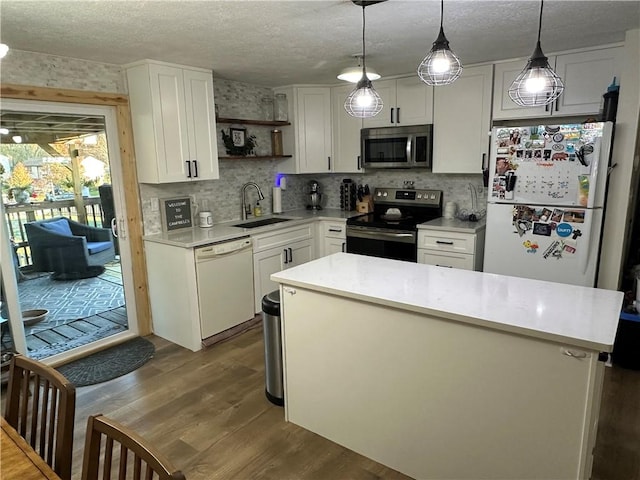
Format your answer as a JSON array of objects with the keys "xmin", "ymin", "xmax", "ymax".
[{"xmin": 275, "ymin": 87, "xmax": 332, "ymax": 173}]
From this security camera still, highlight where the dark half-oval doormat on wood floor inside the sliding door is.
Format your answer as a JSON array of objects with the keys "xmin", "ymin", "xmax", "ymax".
[{"xmin": 56, "ymin": 337, "xmax": 155, "ymax": 387}]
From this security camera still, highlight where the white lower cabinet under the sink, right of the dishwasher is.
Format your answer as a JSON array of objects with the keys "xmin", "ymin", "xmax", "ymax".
[{"xmin": 252, "ymin": 223, "xmax": 315, "ymax": 313}]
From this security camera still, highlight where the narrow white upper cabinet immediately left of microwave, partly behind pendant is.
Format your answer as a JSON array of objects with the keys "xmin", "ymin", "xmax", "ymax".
[{"xmin": 331, "ymin": 84, "xmax": 362, "ymax": 173}]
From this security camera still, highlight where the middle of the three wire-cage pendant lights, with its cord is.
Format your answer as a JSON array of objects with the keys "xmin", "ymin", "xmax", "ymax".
[{"xmin": 418, "ymin": 0, "xmax": 462, "ymax": 86}]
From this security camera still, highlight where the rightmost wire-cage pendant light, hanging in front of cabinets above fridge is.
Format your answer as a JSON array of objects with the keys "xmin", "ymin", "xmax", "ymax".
[{"xmin": 509, "ymin": 0, "xmax": 564, "ymax": 107}]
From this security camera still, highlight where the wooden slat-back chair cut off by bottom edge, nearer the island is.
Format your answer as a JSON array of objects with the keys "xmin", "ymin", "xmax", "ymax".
[{"xmin": 82, "ymin": 415, "xmax": 185, "ymax": 480}]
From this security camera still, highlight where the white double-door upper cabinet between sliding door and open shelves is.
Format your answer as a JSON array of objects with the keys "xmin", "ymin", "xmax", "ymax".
[{"xmin": 126, "ymin": 61, "xmax": 219, "ymax": 183}]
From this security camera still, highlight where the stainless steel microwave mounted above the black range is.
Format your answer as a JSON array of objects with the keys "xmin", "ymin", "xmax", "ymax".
[{"xmin": 360, "ymin": 124, "xmax": 433, "ymax": 168}]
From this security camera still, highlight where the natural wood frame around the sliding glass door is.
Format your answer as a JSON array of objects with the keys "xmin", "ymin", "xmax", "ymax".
[{"xmin": 0, "ymin": 83, "xmax": 152, "ymax": 335}]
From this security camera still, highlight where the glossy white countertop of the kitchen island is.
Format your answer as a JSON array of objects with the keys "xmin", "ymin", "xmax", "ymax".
[{"xmin": 271, "ymin": 253, "xmax": 623, "ymax": 352}]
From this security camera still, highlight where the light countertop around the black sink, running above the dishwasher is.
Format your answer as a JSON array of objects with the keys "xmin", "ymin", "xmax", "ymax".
[{"xmin": 143, "ymin": 209, "xmax": 359, "ymax": 248}]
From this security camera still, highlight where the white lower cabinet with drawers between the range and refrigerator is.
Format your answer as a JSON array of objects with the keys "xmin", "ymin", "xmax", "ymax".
[{"xmin": 418, "ymin": 229, "xmax": 485, "ymax": 271}]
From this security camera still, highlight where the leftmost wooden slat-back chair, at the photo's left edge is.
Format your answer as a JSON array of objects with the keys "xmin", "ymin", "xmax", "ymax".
[{"xmin": 5, "ymin": 355, "xmax": 76, "ymax": 480}]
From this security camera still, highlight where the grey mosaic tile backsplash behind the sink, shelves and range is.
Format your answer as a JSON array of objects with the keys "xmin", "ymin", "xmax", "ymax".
[{"xmin": 140, "ymin": 75, "xmax": 486, "ymax": 235}]
